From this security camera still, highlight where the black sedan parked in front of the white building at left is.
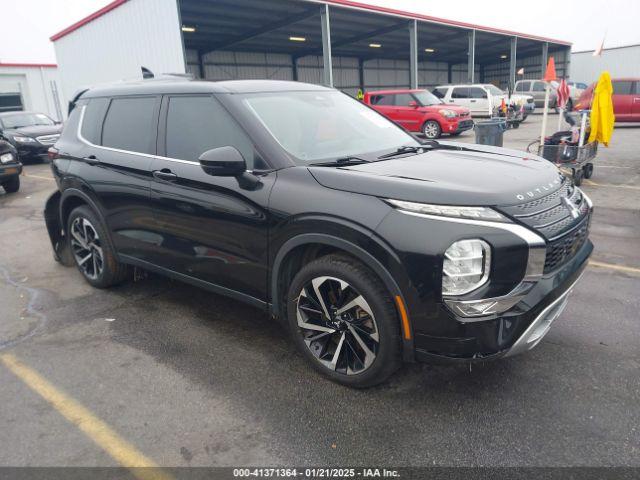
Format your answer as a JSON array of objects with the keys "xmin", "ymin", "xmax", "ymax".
[{"xmin": 0, "ymin": 112, "xmax": 62, "ymax": 161}]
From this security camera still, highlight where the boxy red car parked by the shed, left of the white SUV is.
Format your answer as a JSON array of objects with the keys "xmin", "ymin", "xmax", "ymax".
[{"xmin": 364, "ymin": 90, "xmax": 473, "ymax": 138}]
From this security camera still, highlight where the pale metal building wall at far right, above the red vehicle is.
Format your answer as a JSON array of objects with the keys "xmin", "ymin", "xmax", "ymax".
[{"xmin": 571, "ymin": 45, "xmax": 640, "ymax": 84}]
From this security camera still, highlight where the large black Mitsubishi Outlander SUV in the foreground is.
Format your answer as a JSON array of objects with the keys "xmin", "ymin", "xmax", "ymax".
[{"xmin": 45, "ymin": 79, "xmax": 593, "ymax": 387}]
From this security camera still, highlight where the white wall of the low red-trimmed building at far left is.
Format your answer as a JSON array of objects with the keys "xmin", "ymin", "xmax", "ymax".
[{"xmin": 0, "ymin": 65, "xmax": 66, "ymax": 120}]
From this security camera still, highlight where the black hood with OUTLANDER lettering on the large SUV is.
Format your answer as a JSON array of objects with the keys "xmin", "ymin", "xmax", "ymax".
[{"xmin": 309, "ymin": 142, "xmax": 562, "ymax": 206}]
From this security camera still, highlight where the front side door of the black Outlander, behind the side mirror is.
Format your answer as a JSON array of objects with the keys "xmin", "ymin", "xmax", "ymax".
[{"xmin": 151, "ymin": 95, "xmax": 276, "ymax": 301}]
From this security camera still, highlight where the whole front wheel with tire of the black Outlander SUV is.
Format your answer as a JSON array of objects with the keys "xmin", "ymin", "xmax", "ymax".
[{"xmin": 287, "ymin": 255, "xmax": 400, "ymax": 388}]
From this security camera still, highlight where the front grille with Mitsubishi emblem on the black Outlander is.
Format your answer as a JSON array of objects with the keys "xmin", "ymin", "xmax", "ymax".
[{"xmin": 500, "ymin": 178, "xmax": 591, "ymax": 273}]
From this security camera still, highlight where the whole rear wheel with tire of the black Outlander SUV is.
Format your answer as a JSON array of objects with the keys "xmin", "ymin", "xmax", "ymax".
[{"xmin": 66, "ymin": 205, "xmax": 128, "ymax": 288}]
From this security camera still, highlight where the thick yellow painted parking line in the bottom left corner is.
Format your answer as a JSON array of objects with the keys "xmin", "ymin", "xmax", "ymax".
[{"xmin": 0, "ymin": 353, "xmax": 171, "ymax": 480}]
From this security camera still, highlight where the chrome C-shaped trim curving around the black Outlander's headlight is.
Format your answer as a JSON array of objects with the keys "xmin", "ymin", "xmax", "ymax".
[{"xmin": 397, "ymin": 209, "xmax": 547, "ymax": 322}]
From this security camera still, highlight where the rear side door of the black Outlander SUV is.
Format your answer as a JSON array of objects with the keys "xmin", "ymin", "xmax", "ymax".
[{"xmin": 69, "ymin": 95, "xmax": 161, "ymax": 260}]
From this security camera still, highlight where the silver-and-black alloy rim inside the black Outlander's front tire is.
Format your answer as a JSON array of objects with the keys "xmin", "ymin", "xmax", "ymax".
[{"xmin": 296, "ymin": 277, "xmax": 380, "ymax": 375}]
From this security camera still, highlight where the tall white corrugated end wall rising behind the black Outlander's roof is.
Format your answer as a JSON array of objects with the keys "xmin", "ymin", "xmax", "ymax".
[{"xmin": 54, "ymin": 0, "xmax": 185, "ymax": 110}]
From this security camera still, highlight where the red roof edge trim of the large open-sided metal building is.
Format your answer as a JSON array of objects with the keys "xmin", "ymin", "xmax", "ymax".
[{"xmin": 50, "ymin": 0, "xmax": 571, "ymax": 46}]
